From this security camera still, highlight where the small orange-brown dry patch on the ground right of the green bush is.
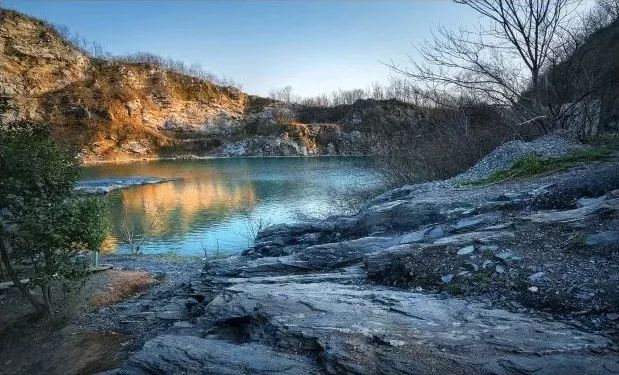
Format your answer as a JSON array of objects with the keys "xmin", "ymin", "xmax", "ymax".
[{"xmin": 92, "ymin": 270, "xmax": 157, "ymax": 307}]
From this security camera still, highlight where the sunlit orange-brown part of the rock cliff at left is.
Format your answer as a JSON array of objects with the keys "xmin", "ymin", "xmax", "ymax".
[{"xmin": 0, "ymin": 10, "xmax": 260, "ymax": 160}]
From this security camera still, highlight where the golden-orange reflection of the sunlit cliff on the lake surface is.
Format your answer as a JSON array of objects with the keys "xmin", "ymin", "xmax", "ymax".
[{"xmin": 81, "ymin": 161, "xmax": 257, "ymax": 237}]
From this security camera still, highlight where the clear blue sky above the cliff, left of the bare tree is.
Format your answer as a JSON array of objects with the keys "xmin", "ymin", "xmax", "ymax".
[{"xmin": 1, "ymin": 0, "xmax": 478, "ymax": 96}]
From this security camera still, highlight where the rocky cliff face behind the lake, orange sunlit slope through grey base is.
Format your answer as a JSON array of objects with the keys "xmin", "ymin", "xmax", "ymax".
[{"xmin": 0, "ymin": 10, "xmax": 376, "ymax": 161}]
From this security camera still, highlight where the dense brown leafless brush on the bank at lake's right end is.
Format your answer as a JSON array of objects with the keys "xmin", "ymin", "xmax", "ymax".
[{"xmin": 372, "ymin": 97, "xmax": 513, "ymax": 186}]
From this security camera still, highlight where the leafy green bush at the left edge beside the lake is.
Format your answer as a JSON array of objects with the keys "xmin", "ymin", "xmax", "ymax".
[{"xmin": 0, "ymin": 124, "xmax": 107, "ymax": 315}]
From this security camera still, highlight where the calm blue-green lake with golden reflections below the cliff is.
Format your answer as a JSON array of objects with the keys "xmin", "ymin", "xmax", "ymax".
[{"xmin": 83, "ymin": 157, "xmax": 381, "ymax": 256}]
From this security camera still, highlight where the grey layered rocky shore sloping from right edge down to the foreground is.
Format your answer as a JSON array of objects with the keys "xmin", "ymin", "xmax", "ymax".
[{"xmin": 98, "ymin": 139, "xmax": 619, "ymax": 374}]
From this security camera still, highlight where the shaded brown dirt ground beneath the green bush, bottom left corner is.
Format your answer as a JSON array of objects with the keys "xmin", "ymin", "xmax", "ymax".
[{"xmin": 0, "ymin": 270, "xmax": 156, "ymax": 375}]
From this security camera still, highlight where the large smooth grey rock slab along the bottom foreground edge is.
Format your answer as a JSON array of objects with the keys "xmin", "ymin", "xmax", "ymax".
[{"xmin": 200, "ymin": 282, "xmax": 619, "ymax": 374}]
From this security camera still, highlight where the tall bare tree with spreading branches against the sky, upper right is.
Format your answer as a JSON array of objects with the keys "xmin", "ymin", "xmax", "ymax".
[{"xmin": 391, "ymin": 0, "xmax": 574, "ymax": 130}]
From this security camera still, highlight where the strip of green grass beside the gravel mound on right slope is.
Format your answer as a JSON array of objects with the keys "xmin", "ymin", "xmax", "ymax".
[{"xmin": 461, "ymin": 148, "xmax": 612, "ymax": 187}]
